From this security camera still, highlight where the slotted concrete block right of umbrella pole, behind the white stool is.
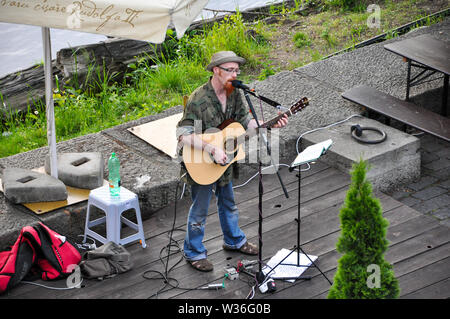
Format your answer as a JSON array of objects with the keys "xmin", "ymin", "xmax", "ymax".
[{"xmin": 45, "ymin": 152, "xmax": 104, "ymax": 189}]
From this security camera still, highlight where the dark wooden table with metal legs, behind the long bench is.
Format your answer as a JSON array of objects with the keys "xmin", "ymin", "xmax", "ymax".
[{"xmin": 384, "ymin": 34, "xmax": 450, "ymax": 116}]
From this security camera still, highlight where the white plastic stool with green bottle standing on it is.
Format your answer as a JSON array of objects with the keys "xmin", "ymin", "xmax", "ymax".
[{"xmin": 84, "ymin": 185, "xmax": 147, "ymax": 248}]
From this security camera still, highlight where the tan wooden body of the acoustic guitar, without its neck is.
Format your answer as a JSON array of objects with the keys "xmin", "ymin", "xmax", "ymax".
[{"xmin": 183, "ymin": 122, "xmax": 245, "ymax": 185}]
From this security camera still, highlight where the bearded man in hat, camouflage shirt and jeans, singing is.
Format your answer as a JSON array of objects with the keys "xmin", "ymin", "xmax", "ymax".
[{"xmin": 177, "ymin": 51, "xmax": 288, "ymax": 271}]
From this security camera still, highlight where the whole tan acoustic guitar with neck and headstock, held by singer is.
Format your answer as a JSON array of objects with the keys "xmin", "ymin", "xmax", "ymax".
[{"xmin": 183, "ymin": 97, "xmax": 309, "ymax": 185}]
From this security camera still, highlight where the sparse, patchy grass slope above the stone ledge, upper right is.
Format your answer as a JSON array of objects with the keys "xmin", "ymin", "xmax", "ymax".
[{"xmin": 270, "ymin": 0, "xmax": 442, "ymax": 70}]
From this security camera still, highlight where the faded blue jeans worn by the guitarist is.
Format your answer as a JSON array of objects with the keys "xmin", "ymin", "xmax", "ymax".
[{"xmin": 184, "ymin": 182, "xmax": 247, "ymax": 260}]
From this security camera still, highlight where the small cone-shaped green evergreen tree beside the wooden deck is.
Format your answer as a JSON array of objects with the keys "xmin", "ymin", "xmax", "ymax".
[{"xmin": 328, "ymin": 160, "xmax": 400, "ymax": 299}]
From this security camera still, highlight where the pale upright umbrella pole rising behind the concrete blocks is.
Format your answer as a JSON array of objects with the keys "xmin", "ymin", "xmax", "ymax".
[{"xmin": 41, "ymin": 27, "xmax": 58, "ymax": 178}]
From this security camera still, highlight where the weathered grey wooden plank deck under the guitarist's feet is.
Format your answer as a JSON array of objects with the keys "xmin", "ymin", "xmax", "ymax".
[{"xmin": 1, "ymin": 163, "xmax": 450, "ymax": 299}]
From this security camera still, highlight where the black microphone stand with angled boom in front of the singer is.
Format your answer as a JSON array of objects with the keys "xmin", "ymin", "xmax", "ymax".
[{"xmin": 240, "ymin": 87, "xmax": 289, "ymax": 284}]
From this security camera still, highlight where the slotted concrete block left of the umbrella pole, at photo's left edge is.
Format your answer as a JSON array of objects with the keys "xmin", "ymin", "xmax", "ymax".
[{"xmin": 2, "ymin": 168, "xmax": 67, "ymax": 204}]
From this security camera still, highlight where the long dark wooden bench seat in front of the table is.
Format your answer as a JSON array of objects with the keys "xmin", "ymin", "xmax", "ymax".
[{"xmin": 342, "ymin": 85, "xmax": 450, "ymax": 141}]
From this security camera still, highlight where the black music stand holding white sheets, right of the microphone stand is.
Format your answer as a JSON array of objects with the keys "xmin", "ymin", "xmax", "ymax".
[{"xmin": 265, "ymin": 139, "xmax": 333, "ymax": 285}]
